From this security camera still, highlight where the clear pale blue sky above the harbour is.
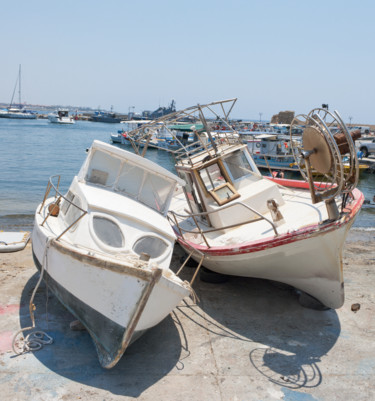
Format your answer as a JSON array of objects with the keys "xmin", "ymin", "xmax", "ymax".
[{"xmin": 0, "ymin": 0, "xmax": 375, "ymax": 124}]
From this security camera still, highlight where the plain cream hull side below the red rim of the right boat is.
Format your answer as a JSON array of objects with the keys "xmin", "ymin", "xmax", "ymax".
[{"xmin": 181, "ymin": 223, "xmax": 351, "ymax": 309}]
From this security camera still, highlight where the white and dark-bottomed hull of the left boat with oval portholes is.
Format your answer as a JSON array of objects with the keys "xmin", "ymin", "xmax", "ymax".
[{"xmin": 32, "ymin": 225, "xmax": 189, "ymax": 368}]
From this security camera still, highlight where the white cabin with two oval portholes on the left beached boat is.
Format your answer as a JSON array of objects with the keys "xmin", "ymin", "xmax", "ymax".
[{"xmin": 52, "ymin": 141, "xmax": 185, "ymax": 268}]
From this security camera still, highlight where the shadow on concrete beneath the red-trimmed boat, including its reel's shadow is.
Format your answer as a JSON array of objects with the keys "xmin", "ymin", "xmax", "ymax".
[{"xmin": 177, "ymin": 264, "xmax": 341, "ymax": 389}]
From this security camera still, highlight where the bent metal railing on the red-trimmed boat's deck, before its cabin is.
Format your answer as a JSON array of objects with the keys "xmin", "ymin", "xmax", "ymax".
[{"xmin": 167, "ymin": 202, "xmax": 279, "ymax": 248}]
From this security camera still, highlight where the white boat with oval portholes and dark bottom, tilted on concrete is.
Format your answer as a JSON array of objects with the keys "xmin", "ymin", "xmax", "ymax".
[{"xmin": 32, "ymin": 141, "xmax": 191, "ymax": 368}]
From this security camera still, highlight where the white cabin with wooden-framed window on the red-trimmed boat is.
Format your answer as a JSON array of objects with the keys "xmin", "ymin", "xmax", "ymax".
[{"xmin": 176, "ymin": 145, "xmax": 284, "ymax": 229}]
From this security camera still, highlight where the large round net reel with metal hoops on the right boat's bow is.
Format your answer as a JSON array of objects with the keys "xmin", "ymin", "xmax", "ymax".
[{"xmin": 290, "ymin": 108, "xmax": 359, "ymax": 220}]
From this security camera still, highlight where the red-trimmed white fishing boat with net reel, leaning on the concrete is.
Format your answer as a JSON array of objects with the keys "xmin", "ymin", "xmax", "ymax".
[{"xmin": 129, "ymin": 99, "xmax": 364, "ymax": 308}]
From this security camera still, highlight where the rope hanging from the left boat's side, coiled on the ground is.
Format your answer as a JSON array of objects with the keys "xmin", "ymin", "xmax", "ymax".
[{"xmin": 12, "ymin": 238, "xmax": 53, "ymax": 355}]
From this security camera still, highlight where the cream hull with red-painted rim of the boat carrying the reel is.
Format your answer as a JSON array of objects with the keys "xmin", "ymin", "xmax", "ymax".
[{"xmin": 175, "ymin": 180, "xmax": 363, "ymax": 309}]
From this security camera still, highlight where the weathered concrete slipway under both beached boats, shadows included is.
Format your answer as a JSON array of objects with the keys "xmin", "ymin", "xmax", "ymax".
[{"xmin": 0, "ymin": 231, "xmax": 375, "ymax": 401}]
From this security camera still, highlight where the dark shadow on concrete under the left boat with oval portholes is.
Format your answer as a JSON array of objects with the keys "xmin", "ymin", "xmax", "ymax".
[{"xmin": 20, "ymin": 273, "xmax": 185, "ymax": 397}]
